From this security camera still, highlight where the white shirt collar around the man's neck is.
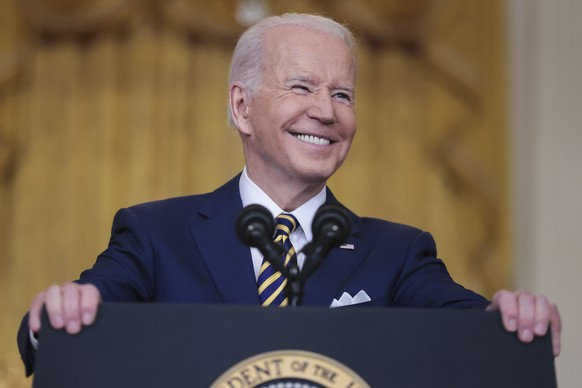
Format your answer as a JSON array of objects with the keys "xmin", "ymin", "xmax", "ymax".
[{"xmin": 239, "ymin": 167, "xmax": 327, "ymax": 241}]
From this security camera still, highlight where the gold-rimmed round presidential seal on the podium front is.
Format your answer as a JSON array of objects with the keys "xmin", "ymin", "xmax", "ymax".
[{"xmin": 211, "ymin": 350, "xmax": 369, "ymax": 388}]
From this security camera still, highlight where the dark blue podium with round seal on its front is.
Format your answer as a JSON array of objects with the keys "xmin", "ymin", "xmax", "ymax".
[{"xmin": 33, "ymin": 303, "xmax": 556, "ymax": 388}]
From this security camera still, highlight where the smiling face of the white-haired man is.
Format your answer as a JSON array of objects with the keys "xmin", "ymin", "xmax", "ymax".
[{"xmin": 239, "ymin": 26, "xmax": 356, "ymax": 191}]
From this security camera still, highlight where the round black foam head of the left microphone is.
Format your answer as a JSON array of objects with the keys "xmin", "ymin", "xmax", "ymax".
[{"xmin": 236, "ymin": 204, "xmax": 275, "ymax": 247}]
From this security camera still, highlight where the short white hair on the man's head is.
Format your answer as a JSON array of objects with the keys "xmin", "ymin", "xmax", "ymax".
[{"xmin": 228, "ymin": 13, "xmax": 356, "ymax": 125}]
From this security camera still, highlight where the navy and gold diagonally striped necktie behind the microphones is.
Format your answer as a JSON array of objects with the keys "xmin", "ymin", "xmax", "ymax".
[{"xmin": 257, "ymin": 213, "xmax": 299, "ymax": 307}]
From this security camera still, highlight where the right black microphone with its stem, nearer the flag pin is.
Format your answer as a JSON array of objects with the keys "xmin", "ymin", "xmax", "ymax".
[{"xmin": 301, "ymin": 204, "xmax": 351, "ymax": 278}]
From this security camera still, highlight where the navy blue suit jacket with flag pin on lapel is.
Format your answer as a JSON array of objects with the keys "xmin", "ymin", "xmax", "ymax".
[{"xmin": 19, "ymin": 176, "xmax": 488, "ymax": 370}]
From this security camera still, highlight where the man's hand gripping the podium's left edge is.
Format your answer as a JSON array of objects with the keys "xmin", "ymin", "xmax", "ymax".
[{"xmin": 28, "ymin": 283, "xmax": 101, "ymax": 334}]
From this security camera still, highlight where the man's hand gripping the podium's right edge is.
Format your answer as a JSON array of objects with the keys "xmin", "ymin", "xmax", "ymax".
[{"xmin": 487, "ymin": 290, "xmax": 562, "ymax": 356}]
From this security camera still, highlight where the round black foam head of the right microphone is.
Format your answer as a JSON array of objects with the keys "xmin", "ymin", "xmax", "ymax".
[{"xmin": 311, "ymin": 204, "xmax": 351, "ymax": 244}]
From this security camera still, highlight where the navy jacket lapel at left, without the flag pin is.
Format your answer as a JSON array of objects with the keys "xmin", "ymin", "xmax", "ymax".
[{"xmin": 191, "ymin": 176, "xmax": 259, "ymax": 304}]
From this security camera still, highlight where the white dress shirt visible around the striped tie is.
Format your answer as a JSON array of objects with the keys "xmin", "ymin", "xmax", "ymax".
[{"xmin": 239, "ymin": 167, "xmax": 326, "ymax": 279}]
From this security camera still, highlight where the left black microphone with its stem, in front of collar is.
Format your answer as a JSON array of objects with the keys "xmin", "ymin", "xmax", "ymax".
[{"xmin": 236, "ymin": 204, "xmax": 287, "ymax": 274}]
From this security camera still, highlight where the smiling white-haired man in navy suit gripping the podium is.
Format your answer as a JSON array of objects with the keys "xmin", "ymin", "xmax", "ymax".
[{"xmin": 19, "ymin": 14, "xmax": 561, "ymax": 373}]
